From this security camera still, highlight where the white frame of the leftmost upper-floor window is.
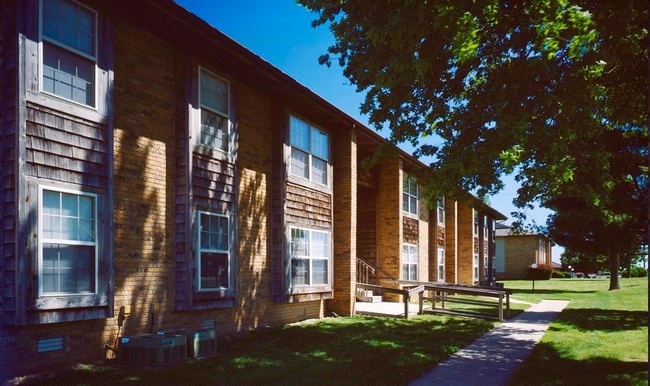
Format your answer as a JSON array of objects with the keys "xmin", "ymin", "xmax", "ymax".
[{"xmin": 38, "ymin": 0, "xmax": 100, "ymax": 111}]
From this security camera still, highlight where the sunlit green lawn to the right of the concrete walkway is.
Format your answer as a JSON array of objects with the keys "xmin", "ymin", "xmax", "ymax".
[{"xmin": 505, "ymin": 278, "xmax": 648, "ymax": 385}]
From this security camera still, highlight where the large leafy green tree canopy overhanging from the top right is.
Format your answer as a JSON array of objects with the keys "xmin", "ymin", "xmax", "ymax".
[{"xmin": 298, "ymin": 0, "xmax": 648, "ymax": 288}]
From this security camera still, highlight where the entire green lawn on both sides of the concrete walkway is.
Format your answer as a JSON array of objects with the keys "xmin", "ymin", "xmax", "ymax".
[{"xmin": 16, "ymin": 278, "xmax": 648, "ymax": 385}]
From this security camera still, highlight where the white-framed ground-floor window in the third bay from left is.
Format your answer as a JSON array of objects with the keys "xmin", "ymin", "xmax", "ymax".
[{"xmin": 290, "ymin": 228, "xmax": 330, "ymax": 286}]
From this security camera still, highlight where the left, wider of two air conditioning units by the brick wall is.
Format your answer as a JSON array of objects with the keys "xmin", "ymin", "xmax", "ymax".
[{"xmin": 117, "ymin": 334, "xmax": 187, "ymax": 366}]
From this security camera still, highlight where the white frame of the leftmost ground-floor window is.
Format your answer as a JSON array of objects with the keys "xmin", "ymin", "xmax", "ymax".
[{"xmin": 38, "ymin": 185, "xmax": 99, "ymax": 297}]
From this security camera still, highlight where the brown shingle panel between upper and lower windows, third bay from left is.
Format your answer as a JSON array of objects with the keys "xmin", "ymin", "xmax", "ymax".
[{"xmin": 286, "ymin": 183, "xmax": 332, "ymax": 230}]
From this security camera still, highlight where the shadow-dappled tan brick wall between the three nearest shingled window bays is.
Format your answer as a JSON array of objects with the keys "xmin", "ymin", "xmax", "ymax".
[{"xmin": 0, "ymin": 18, "xmax": 330, "ymax": 379}]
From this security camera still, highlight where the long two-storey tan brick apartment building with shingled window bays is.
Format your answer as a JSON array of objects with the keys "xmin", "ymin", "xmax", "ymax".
[{"xmin": 0, "ymin": 0, "xmax": 505, "ymax": 379}]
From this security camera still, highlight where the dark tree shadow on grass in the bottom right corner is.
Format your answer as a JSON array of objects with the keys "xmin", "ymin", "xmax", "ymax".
[{"xmin": 508, "ymin": 342, "xmax": 648, "ymax": 386}]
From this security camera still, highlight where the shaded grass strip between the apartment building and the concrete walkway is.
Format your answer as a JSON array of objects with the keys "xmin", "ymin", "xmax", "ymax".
[{"xmin": 17, "ymin": 315, "xmax": 496, "ymax": 385}]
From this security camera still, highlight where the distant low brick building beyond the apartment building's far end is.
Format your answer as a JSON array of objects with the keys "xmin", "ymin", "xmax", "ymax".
[{"xmin": 495, "ymin": 225, "xmax": 553, "ymax": 280}]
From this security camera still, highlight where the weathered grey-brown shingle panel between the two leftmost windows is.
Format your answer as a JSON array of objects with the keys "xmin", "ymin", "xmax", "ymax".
[{"xmin": 25, "ymin": 103, "xmax": 109, "ymax": 188}]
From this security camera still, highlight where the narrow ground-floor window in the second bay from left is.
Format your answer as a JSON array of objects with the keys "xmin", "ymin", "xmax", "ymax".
[{"xmin": 197, "ymin": 212, "xmax": 230, "ymax": 291}]
